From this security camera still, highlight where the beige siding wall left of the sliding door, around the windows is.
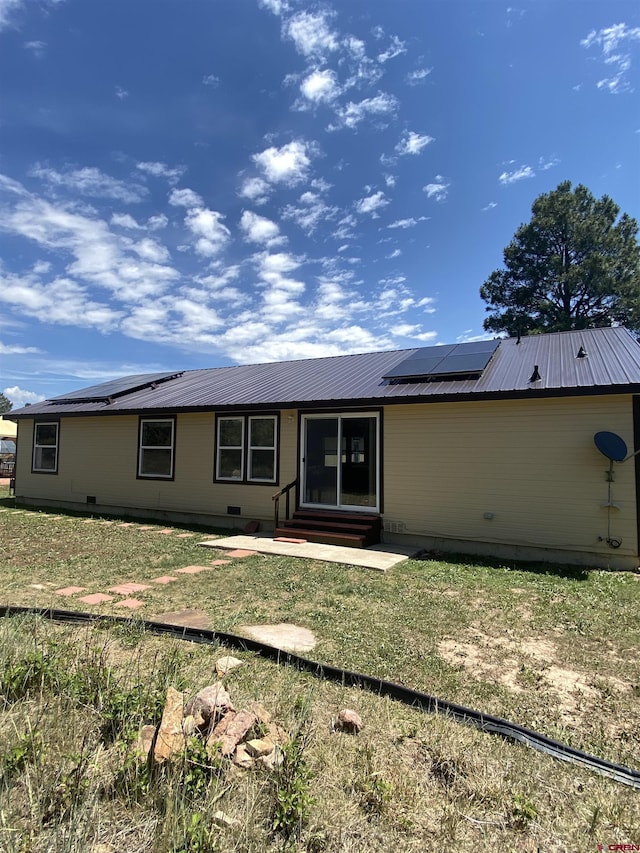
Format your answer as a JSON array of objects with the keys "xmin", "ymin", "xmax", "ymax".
[{"xmin": 16, "ymin": 411, "xmax": 297, "ymax": 519}]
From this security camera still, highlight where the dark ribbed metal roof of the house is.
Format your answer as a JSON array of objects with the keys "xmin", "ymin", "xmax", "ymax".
[{"xmin": 10, "ymin": 327, "xmax": 640, "ymax": 419}]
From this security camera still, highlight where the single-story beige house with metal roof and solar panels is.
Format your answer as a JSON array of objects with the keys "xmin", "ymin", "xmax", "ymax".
[{"xmin": 10, "ymin": 328, "xmax": 640, "ymax": 568}]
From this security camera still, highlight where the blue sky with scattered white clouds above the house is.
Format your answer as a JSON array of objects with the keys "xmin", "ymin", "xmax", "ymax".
[{"xmin": 0, "ymin": 0, "xmax": 640, "ymax": 406}]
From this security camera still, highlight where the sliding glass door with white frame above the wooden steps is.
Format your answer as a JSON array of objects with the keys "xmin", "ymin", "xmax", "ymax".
[{"xmin": 300, "ymin": 412, "xmax": 380, "ymax": 512}]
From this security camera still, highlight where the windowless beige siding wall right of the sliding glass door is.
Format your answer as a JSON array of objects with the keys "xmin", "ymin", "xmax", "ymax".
[{"xmin": 384, "ymin": 395, "xmax": 638, "ymax": 556}]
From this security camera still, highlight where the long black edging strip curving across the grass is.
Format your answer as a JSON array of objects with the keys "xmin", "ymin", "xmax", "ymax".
[{"xmin": 0, "ymin": 606, "xmax": 640, "ymax": 790}]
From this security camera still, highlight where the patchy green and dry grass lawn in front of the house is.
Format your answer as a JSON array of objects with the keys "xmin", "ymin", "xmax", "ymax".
[{"xmin": 0, "ymin": 490, "xmax": 640, "ymax": 853}]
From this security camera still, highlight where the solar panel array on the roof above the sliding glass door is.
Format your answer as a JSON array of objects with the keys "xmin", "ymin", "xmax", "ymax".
[{"xmin": 383, "ymin": 340, "xmax": 500, "ymax": 382}]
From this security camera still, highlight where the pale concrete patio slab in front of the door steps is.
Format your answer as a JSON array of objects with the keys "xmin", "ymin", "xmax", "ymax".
[{"xmin": 198, "ymin": 534, "xmax": 421, "ymax": 572}]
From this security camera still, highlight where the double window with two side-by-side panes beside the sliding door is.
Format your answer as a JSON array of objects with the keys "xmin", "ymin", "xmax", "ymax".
[{"xmin": 216, "ymin": 415, "xmax": 278, "ymax": 483}]
